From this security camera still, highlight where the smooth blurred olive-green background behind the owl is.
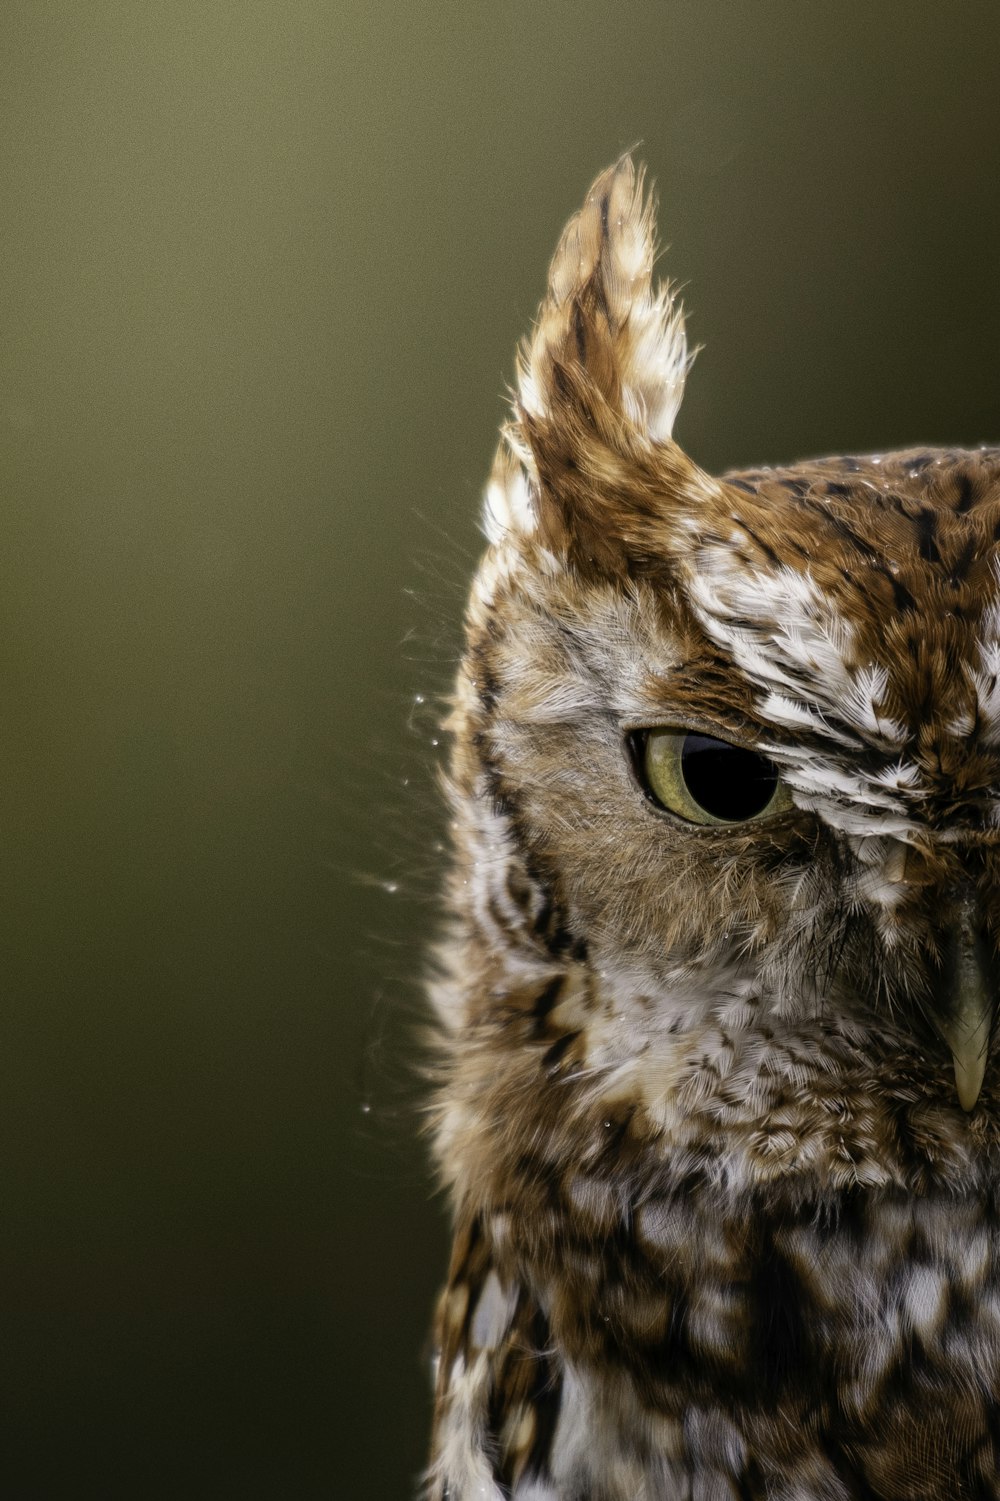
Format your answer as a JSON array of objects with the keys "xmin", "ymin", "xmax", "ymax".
[{"xmin": 0, "ymin": 0, "xmax": 1000, "ymax": 1501}]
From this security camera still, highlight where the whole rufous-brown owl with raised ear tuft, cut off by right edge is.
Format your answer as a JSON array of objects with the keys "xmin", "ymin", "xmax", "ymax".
[{"xmin": 425, "ymin": 159, "xmax": 1000, "ymax": 1501}]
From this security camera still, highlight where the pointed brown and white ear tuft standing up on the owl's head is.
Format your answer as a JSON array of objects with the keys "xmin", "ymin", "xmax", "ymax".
[{"xmin": 485, "ymin": 156, "xmax": 718, "ymax": 573}]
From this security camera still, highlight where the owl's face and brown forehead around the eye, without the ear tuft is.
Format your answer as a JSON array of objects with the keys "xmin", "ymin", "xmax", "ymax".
[{"xmin": 476, "ymin": 435, "xmax": 1000, "ymax": 1108}]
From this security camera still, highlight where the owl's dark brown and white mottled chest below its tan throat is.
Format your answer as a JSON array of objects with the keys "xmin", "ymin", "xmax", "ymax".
[{"xmin": 432, "ymin": 1050, "xmax": 1000, "ymax": 1501}]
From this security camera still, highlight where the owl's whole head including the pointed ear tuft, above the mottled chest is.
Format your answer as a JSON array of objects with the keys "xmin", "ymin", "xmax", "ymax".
[{"xmin": 438, "ymin": 158, "xmax": 1000, "ymax": 1206}]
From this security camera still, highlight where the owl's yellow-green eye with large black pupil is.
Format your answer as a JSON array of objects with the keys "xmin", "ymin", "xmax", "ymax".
[{"xmin": 635, "ymin": 729, "xmax": 791, "ymax": 824}]
